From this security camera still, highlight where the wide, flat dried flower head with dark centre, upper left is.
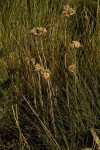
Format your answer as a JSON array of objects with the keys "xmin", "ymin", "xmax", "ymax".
[{"xmin": 31, "ymin": 27, "xmax": 47, "ymax": 36}]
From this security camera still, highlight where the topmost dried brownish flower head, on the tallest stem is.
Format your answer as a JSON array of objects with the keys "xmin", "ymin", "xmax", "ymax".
[{"xmin": 63, "ymin": 5, "xmax": 76, "ymax": 17}]
